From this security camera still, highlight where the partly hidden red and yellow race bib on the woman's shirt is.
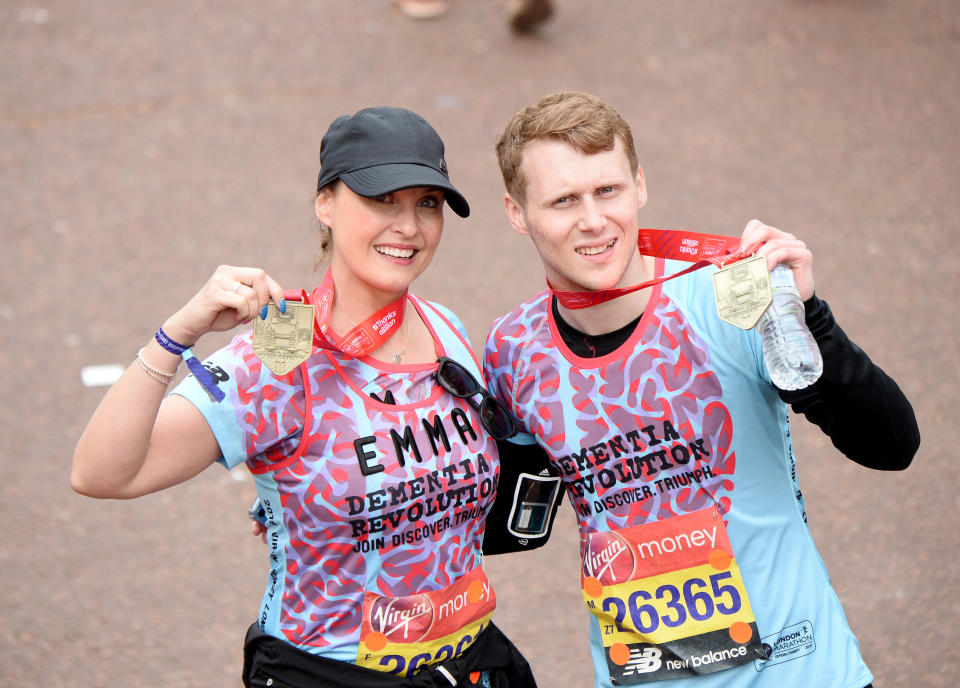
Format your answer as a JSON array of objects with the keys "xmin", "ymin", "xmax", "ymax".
[{"xmin": 357, "ymin": 566, "xmax": 497, "ymax": 676}]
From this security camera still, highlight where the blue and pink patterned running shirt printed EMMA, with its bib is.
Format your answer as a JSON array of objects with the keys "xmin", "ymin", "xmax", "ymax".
[{"xmin": 175, "ymin": 296, "xmax": 499, "ymax": 676}]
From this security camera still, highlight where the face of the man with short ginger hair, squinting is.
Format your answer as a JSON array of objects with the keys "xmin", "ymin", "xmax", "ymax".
[{"xmin": 505, "ymin": 139, "xmax": 647, "ymax": 291}]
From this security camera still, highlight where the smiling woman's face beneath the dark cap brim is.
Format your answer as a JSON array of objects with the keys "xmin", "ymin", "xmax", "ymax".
[{"xmin": 316, "ymin": 183, "xmax": 443, "ymax": 303}]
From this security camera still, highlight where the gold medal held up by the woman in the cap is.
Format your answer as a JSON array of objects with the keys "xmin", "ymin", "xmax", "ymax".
[{"xmin": 253, "ymin": 301, "xmax": 313, "ymax": 375}]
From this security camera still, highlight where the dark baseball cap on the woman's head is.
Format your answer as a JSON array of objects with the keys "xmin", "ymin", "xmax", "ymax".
[{"xmin": 317, "ymin": 107, "xmax": 470, "ymax": 217}]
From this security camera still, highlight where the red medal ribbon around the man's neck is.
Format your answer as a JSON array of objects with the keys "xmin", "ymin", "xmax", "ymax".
[{"xmin": 547, "ymin": 229, "xmax": 760, "ymax": 310}]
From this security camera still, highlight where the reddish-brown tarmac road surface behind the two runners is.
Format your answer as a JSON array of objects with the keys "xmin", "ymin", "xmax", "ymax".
[{"xmin": 0, "ymin": 0, "xmax": 960, "ymax": 688}]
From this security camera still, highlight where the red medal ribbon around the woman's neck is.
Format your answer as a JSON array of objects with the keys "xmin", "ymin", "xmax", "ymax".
[{"xmin": 287, "ymin": 269, "xmax": 407, "ymax": 357}]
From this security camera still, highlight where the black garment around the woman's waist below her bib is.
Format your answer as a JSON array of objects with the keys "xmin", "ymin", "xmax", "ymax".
[{"xmin": 243, "ymin": 623, "xmax": 537, "ymax": 688}]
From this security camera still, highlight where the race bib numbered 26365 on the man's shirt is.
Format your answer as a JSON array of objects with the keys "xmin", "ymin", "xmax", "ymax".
[{"xmin": 581, "ymin": 507, "xmax": 764, "ymax": 685}]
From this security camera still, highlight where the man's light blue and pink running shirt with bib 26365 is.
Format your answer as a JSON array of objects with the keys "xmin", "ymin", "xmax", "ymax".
[{"xmin": 484, "ymin": 260, "xmax": 872, "ymax": 688}]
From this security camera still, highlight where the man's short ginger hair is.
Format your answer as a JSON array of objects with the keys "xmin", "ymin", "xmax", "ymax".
[{"xmin": 497, "ymin": 91, "xmax": 639, "ymax": 204}]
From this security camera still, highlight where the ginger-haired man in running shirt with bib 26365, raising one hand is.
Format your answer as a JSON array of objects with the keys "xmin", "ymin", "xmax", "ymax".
[{"xmin": 485, "ymin": 93, "xmax": 919, "ymax": 688}]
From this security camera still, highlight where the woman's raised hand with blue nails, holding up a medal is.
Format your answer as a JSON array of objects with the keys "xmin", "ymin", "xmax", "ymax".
[{"xmin": 163, "ymin": 265, "xmax": 286, "ymax": 346}]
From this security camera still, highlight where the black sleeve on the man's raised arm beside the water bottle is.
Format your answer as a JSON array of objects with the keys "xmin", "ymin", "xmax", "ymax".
[{"xmin": 777, "ymin": 294, "xmax": 920, "ymax": 471}]
